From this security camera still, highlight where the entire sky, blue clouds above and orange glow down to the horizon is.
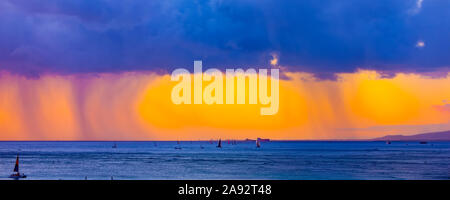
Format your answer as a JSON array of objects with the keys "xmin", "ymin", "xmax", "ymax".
[{"xmin": 0, "ymin": 0, "xmax": 450, "ymax": 140}]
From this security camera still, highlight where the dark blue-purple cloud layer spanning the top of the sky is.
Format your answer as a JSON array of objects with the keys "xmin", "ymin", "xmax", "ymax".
[{"xmin": 0, "ymin": 0, "xmax": 450, "ymax": 76}]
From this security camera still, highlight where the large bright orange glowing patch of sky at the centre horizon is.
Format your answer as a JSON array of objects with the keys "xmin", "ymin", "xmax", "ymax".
[{"xmin": 137, "ymin": 72, "xmax": 307, "ymax": 139}]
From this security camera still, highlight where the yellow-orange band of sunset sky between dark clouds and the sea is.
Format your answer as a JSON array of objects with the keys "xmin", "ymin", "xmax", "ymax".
[{"xmin": 0, "ymin": 71, "xmax": 450, "ymax": 140}]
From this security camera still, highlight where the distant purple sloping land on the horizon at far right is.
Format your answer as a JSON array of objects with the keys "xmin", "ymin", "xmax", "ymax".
[{"xmin": 372, "ymin": 130, "xmax": 450, "ymax": 141}]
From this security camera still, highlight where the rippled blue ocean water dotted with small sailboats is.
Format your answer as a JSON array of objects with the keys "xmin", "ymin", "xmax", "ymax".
[{"xmin": 0, "ymin": 141, "xmax": 450, "ymax": 180}]
